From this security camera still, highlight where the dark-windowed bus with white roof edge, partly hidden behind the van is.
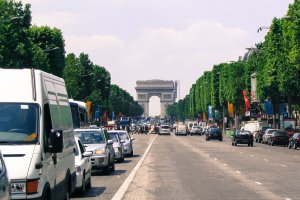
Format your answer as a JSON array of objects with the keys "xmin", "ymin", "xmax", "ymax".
[{"xmin": 69, "ymin": 99, "xmax": 89, "ymax": 128}]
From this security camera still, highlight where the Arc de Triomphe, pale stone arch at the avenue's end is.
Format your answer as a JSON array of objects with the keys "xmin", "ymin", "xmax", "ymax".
[{"xmin": 135, "ymin": 80, "xmax": 177, "ymax": 117}]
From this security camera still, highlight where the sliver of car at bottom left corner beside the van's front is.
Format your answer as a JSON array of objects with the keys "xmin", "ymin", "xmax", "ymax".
[{"xmin": 0, "ymin": 151, "xmax": 10, "ymax": 200}]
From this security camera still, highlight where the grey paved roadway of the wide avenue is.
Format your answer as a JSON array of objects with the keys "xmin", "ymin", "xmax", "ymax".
[{"xmin": 73, "ymin": 134, "xmax": 300, "ymax": 200}]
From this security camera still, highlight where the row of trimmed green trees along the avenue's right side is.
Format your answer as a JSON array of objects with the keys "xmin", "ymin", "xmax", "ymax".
[{"xmin": 167, "ymin": 0, "xmax": 300, "ymax": 128}]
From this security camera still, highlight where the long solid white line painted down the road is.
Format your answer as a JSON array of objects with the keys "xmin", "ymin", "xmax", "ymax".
[{"xmin": 111, "ymin": 135, "xmax": 158, "ymax": 200}]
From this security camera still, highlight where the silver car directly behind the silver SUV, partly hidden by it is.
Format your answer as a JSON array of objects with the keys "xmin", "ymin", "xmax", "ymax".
[{"xmin": 108, "ymin": 131, "xmax": 125, "ymax": 162}]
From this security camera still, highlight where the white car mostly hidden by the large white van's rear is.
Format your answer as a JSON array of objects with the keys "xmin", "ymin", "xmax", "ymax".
[{"xmin": 75, "ymin": 136, "xmax": 93, "ymax": 194}]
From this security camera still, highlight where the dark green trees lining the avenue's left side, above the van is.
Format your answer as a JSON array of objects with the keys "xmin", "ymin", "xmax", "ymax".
[{"xmin": 0, "ymin": 0, "xmax": 143, "ymax": 118}]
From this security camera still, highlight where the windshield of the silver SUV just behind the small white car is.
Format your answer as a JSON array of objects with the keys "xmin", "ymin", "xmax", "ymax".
[{"xmin": 75, "ymin": 131, "xmax": 105, "ymax": 144}]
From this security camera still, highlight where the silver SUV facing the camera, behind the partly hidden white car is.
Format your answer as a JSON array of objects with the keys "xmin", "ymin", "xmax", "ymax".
[{"xmin": 74, "ymin": 128, "xmax": 115, "ymax": 174}]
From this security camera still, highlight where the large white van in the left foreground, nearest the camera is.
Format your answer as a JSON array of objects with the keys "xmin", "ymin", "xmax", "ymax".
[{"xmin": 0, "ymin": 69, "xmax": 76, "ymax": 199}]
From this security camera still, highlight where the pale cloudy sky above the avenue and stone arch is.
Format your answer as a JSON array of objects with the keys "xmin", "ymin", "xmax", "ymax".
[{"xmin": 22, "ymin": 0, "xmax": 294, "ymax": 114}]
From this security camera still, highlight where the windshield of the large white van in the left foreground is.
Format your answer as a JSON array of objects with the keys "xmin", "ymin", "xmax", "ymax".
[{"xmin": 0, "ymin": 103, "xmax": 39, "ymax": 144}]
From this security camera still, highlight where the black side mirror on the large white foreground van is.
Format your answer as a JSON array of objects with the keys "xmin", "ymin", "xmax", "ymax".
[{"xmin": 48, "ymin": 129, "xmax": 63, "ymax": 153}]
